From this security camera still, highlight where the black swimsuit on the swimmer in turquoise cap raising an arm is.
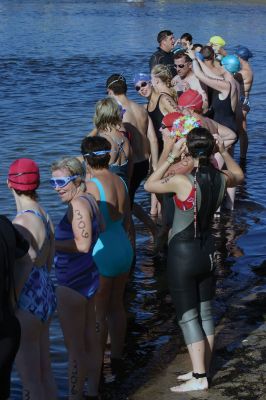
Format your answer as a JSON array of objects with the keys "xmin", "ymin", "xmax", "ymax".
[{"xmin": 211, "ymin": 84, "xmax": 236, "ymax": 132}]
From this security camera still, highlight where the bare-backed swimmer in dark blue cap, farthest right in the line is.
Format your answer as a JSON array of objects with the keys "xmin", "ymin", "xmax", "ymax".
[{"xmin": 235, "ymin": 46, "xmax": 253, "ymax": 160}]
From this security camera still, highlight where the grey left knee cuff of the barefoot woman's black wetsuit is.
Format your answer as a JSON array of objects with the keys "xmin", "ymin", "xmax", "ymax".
[{"xmin": 178, "ymin": 308, "xmax": 204, "ymax": 345}]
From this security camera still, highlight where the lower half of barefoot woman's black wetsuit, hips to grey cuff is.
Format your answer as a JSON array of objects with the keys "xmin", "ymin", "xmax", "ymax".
[{"xmin": 167, "ymin": 235, "xmax": 215, "ymax": 344}]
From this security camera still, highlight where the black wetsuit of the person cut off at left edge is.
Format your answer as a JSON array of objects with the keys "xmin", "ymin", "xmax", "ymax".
[{"xmin": 0, "ymin": 216, "xmax": 29, "ymax": 400}]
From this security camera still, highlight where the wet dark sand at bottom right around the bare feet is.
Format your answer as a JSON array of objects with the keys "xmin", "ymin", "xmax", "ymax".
[{"xmin": 128, "ymin": 271, "xmax": 266, "ymax": 400}]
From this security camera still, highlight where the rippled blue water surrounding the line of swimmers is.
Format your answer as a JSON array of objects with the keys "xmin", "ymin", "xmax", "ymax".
[{"xmin": 0, "ymin": 0, "xmax": 266, "ymax": 399}]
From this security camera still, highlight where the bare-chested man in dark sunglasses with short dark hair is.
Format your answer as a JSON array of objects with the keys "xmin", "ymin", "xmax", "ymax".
[{"xmin": 173, "ymin": 52, "xmax": 208, "ymax": 113}]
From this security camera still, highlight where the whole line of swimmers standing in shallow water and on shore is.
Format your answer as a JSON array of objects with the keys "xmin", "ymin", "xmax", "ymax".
[{"xmin": 0, "ymin": 30, "xmax": 252, "ymax": 400}]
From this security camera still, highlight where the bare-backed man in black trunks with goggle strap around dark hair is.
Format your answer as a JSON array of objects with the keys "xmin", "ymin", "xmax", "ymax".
[{"xmin": 106, "ymin": 74, "xmax": 157, "ymax": 236}]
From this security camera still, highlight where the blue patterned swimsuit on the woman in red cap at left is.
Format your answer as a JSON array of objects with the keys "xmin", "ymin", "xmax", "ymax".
[{"xmin": 17, "ymin": 210, "xmax": 56, "ymax": 322}]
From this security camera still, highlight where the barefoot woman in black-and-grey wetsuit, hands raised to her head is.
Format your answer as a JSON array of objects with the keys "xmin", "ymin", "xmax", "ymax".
[{"xmin": 144, "ymin": 128, "xmax": 244, "ymax": 392}]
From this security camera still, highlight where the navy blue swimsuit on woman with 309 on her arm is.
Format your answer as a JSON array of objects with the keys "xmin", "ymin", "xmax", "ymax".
[{"xmin": 55, "ymin": 193, "xmax": 100, "ymax": 298}]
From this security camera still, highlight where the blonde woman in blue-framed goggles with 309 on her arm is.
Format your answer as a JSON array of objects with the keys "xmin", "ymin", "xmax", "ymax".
[{"xmin": 50, "ymin": 158, "xmax": 102, "ymax": 400}]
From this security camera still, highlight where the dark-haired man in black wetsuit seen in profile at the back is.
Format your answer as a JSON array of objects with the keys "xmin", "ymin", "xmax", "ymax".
[{"xmin": 149, "ymin": 30, "xmax": 176, "ymax": 76}]
